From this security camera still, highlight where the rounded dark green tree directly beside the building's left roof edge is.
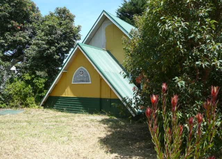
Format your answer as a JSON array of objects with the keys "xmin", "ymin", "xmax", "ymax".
[{"xmin": 23, "ymin": 7, "xmax": 80, "ymax": 85}]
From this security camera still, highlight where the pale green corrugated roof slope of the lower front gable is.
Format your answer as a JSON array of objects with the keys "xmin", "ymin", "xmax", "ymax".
[{"xmin": 78, "ymin": 43, "xmax": 137, "ymax": 113}]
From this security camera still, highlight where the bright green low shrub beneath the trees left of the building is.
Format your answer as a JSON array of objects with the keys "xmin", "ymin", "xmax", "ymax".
[{"xmin": 0, "ymin": 74, "xmax": 46, "ymax": 107}]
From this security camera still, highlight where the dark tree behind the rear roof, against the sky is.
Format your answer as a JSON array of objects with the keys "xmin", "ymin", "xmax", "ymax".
[{"xmin": 117, "ymin": 0, "xmax": 146, "ymax": 25}]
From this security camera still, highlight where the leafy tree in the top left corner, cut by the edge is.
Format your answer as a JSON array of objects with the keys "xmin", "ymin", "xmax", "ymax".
[{"xmin": 0, "ymin": 0, "xmax": 41, "ymax": 69}]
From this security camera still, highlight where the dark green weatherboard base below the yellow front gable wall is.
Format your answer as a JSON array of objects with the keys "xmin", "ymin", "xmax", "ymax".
[{"xmin": 45, "ymin": 96, "xmax": 129, "ymax": 116}]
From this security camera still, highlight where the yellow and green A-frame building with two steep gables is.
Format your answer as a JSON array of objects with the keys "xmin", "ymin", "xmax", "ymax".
[{"xmin": 41, "ymin": 11, "xmax": 138, "ymax": 116}]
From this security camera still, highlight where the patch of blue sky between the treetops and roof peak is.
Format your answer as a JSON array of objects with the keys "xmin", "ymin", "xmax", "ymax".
[{"xmin": 32, "ymin": 0, "xmax": 123, "ymax": 40}]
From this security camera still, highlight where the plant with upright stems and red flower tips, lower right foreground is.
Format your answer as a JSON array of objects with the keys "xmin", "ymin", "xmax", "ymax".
[{"xmin": 145, "ymin": 83, "xmax": 220, "ymax": 159}]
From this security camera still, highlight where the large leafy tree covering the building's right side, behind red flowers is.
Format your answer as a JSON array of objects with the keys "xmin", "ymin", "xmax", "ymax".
[{"xmin": 125, "ymin": 0, "xmax": 222, "ymax": 155}]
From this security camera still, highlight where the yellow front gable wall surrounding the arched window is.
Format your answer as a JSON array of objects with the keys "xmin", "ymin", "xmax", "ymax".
[{"xmin": 50, "ymin": 49, "xmax": 118, "ymax": 99}]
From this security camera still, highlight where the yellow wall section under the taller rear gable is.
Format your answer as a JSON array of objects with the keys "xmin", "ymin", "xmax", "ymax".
[{"xmin": 106, "ymin": 24, "xmax": 126, "ymax": 64}]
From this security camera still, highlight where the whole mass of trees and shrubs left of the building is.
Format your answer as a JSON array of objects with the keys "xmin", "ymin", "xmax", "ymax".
[{"xmin": 0, "ymin": 0, "xmax": 80, "ymax": 106}]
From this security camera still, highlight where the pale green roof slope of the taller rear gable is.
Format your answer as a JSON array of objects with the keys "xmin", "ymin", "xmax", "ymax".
[{"xmin": 103, "ymin": 11, "xmax": 136, "ymax": 34}]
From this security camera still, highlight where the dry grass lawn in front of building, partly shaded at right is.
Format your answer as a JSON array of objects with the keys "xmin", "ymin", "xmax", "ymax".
[{"xmin": 0, "ymin": 109, "xmax": 155, "ymax": 159}]
